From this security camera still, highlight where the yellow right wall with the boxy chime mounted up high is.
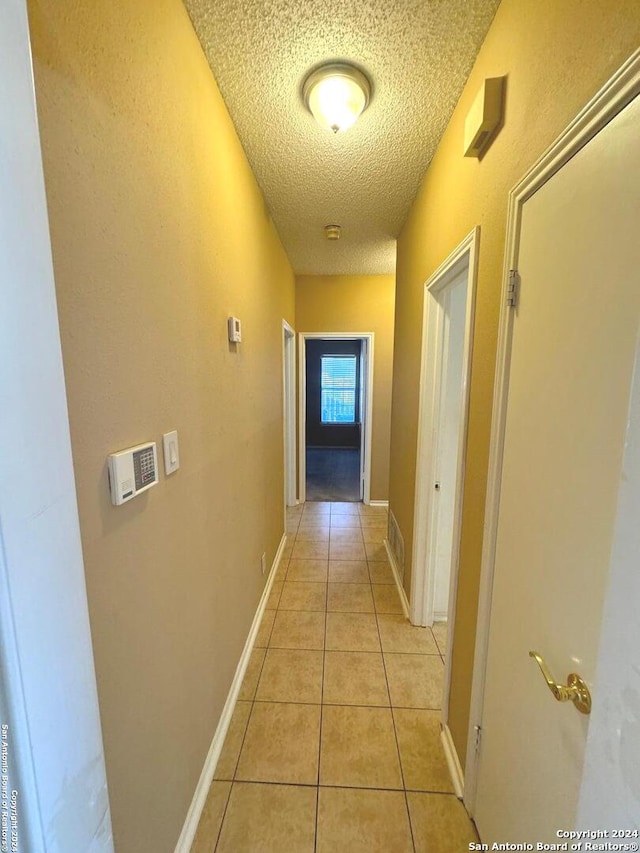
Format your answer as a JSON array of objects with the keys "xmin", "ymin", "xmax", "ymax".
[{"xmin": 390, "ymin": 0, "xmax": 640, "ymax": 762}]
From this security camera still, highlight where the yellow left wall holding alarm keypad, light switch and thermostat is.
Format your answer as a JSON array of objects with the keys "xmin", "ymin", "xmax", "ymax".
[{"xmin": 27, "ymin": 0, "xmax": 294, "ymax": 853}]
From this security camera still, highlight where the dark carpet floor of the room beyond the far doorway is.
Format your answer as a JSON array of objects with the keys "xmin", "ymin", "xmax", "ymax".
[{"xmin": 307, "ymin": 447, "xmax": 360, "ymax": 501}]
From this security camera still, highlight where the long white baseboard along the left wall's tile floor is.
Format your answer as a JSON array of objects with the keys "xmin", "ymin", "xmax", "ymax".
[{"xmin": 175, "ymin": 533, "xmax": 287, "ymax": 853}]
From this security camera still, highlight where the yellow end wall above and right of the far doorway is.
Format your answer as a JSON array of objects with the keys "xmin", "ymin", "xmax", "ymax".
[{"xmin": 296, "ymin": 275, "xmax": 395, "ymax": 501}]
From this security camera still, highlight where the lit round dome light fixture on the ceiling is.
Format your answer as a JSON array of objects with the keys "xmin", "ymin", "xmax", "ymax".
[{"xmin": 302, "ymin": 62, "xmax": 371, "ymax": 133}]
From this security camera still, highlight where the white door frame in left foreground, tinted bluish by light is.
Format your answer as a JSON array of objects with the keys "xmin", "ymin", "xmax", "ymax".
[{"xmin": 0, "ymin": 0, "xmax": 113, "ymax": 853}]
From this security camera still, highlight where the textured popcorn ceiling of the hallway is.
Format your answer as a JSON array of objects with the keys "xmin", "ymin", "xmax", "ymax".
[{"xmin": 180, "ymin": 0, "xmax": 499, "ymax": 275}]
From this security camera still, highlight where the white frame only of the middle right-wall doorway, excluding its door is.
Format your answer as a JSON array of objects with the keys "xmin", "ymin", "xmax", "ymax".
[{"xmin": 410, "ymin": 228, "xmax": 480, "ymax": 624}]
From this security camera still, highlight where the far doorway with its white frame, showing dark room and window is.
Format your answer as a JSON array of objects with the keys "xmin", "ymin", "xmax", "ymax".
[{"xmin": 299, "ymin": 333, "xmax": 373, "ymax": 503}]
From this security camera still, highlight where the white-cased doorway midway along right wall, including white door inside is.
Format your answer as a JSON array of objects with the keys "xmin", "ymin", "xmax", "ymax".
[{"xmin": 411, "ymin": 228, "xmax": 480, "ymax": 632}]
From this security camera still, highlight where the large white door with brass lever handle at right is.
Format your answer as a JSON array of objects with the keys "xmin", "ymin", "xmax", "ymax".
[{"xmin": 475, "ymin": 88, "xmax": 640, "ymax": 843}]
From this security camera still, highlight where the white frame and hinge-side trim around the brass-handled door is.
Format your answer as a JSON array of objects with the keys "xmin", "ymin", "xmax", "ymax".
[{"xmin": 464, "ymin": 50, "xmax": 640, "ymax": 815}]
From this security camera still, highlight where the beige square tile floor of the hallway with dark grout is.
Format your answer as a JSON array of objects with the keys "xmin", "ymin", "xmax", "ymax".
[{"xmin": 191, "ymin": 503, "xmax": 477, "ymax": 853}]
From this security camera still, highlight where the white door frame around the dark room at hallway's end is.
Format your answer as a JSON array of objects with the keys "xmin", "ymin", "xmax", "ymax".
[{"xmin": 298, "ymin": 332, "xmax": 375, "ymax": 504}]
